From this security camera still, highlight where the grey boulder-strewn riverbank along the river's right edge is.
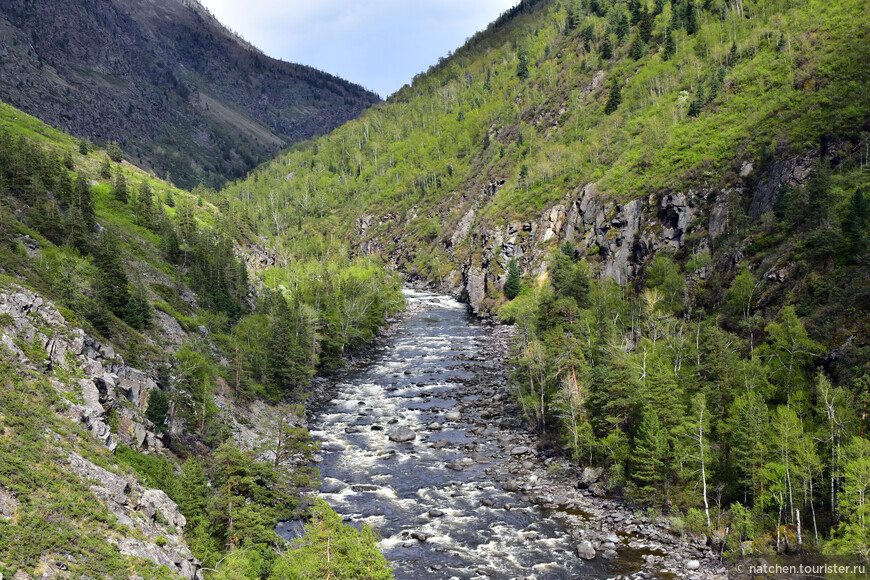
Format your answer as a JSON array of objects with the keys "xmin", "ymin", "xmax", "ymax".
[{"xmin": 450, "ymin": 324, "xmax": 728, "ymax": 580}]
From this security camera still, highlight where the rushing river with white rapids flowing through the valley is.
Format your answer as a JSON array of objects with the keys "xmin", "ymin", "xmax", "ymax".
[{"xmin": 304, "ymin": 290, "xmax": 640, "ymax": 580}]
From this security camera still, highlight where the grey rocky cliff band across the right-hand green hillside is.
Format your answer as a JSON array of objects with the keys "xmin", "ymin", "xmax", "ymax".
[{"xmin": 356, "ymin": 144, "xmax": 832, "ymax": 315}]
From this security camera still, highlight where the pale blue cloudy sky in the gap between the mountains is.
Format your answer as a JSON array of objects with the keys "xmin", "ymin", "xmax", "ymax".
[{"xmin": 200, "ymin": 0, "xmax": 518, "ymax": 98}]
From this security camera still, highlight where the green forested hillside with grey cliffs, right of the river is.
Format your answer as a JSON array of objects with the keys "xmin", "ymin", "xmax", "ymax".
[{"xmin": 214, "ymin": 0, "xmax": 870, "ymax": 556}]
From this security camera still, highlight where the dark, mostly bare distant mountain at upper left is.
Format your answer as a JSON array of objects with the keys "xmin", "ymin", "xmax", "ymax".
[{"xmin": 0, "ymin": 0, "xmax": 378, "ymax": 187}]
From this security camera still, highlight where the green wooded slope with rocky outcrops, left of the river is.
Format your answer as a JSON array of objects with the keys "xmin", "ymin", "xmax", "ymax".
[{"xmin": 0, "ymin": 104, "xmax": 402, "ymax": 578}]
